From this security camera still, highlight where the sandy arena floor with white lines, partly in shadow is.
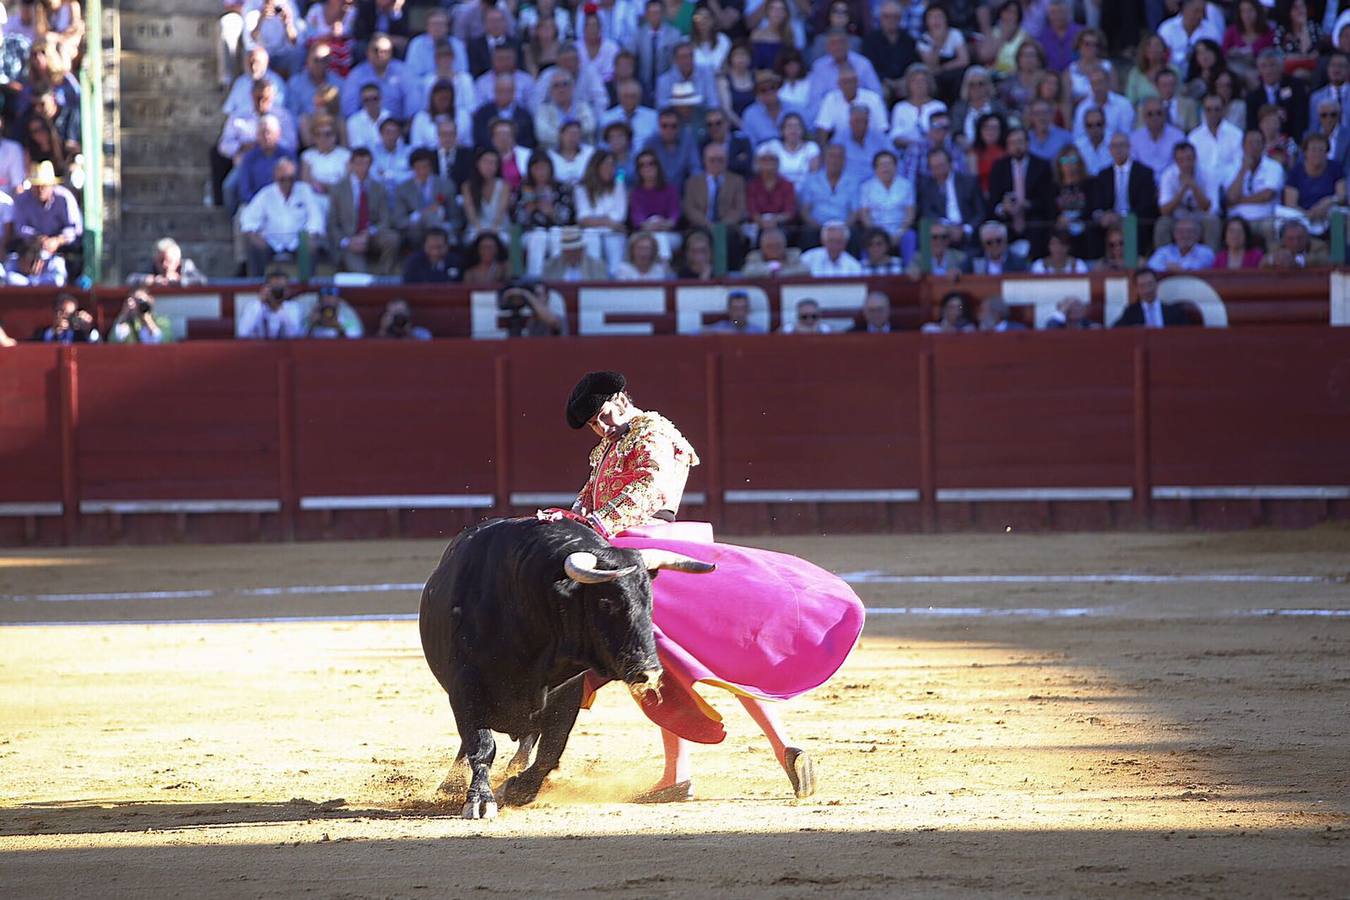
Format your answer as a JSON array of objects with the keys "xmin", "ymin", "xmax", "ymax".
[{"xmin": 0, "ymin": 529, "xmax": 1350, "ymax": 897}]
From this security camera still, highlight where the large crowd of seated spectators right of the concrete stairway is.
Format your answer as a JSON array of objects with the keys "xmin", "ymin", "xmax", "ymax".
[{"xmin": 207, "ymin": 0, "xmax": 1350, "ymax": 281}]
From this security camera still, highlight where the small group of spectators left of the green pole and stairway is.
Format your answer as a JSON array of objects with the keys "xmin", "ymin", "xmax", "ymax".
[{"xmin": 0, "ymin": 0, "xmax": 85, "ymax": 286}]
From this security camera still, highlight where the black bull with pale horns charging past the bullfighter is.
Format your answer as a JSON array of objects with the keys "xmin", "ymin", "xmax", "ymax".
[{"xmin": 420, "ymin": 518, "xmax": 713, "ymax": 819}]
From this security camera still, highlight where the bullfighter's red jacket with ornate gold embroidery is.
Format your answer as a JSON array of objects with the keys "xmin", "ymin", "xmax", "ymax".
[{"xmin": 572, "ymin": 413, "xmax": 698, "ymax": 534}]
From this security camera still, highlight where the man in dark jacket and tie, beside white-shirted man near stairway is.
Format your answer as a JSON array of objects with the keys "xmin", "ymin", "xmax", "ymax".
[{"xmin": 327, "ymin": 147, "xmax": 400, "ymax": 275}]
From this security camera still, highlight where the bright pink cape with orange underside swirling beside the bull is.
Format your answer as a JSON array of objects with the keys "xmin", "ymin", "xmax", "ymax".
[{"xmin": 587, "ymin": 522, "xmax": 864, "ymax": 743}]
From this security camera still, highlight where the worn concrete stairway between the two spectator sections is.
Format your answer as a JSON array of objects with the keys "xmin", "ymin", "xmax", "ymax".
[{"xmin": 115, "ymin": 0, "xmax": 234, "ymax": 281}]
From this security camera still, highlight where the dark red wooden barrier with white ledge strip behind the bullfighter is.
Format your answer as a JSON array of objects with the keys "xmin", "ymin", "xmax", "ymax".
[{"xmin": 0, "ymin": 328, "xmax": 1350, "ymax": 544}]
